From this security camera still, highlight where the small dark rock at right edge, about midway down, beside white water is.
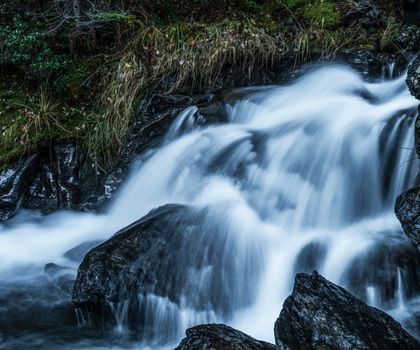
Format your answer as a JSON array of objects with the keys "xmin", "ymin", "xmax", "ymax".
[{"xmin": 395, "ymin": 187, "xmax": 420, "ymax": 251}]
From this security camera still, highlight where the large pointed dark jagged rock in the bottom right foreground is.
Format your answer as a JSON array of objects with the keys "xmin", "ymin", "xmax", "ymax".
[{"xmin": 274, "ymin": 272, "xmax": 420, "ymax": 350}]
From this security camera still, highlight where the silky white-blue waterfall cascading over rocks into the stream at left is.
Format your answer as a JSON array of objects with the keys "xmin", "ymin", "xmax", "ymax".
[{"xmin": 0, "ymin": 66, "xmax": 420, "ymax": 348}]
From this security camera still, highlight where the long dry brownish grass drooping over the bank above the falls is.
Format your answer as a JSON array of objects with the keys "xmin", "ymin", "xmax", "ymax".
[{"xmin": 89, "ymin": 22, "xmax": 288, "ymax": 166}]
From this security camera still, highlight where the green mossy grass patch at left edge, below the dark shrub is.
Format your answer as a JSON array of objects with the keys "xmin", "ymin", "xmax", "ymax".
[{"xmin": 0, "ymin": 84, "xmax": 88, "ymax": 166}]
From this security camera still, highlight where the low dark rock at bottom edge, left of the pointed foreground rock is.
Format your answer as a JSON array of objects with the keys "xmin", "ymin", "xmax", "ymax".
[{"xmin": 175, "ymin": 324, "xmax": 276, "ymax": 350}]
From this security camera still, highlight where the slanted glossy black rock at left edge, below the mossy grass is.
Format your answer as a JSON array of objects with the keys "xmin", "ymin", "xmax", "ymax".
[{"xmin": 0, "ymin": 154, "xmax": 39, "ymax": 221}]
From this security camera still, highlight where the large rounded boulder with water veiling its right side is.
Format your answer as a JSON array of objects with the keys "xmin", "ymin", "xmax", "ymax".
[{"xmin": 72, "ymin": 204, "xmax": 258, "ymax": 320}]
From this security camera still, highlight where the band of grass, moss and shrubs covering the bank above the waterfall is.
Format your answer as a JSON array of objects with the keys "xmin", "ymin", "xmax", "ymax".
[{"xmin": 0, "ymin": 0, "xmax": 414, "ymax": 169}]
